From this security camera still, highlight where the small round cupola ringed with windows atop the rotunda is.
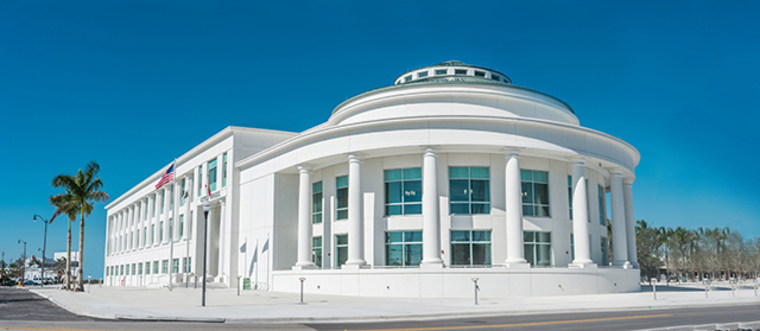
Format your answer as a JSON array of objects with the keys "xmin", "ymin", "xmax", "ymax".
[{"xmin": 393, "ymin": 60, "xmax": 512, "ymax": 85}]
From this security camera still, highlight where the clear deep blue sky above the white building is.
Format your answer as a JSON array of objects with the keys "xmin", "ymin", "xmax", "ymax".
[{"xmin": 0, "ymin": 0, "xmax": 760, "ymax": 278}]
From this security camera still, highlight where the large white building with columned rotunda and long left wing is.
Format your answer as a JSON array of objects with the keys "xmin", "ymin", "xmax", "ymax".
[{"xmin": 105, "ymin": 61, "xmax": 640, "ymax": 297}]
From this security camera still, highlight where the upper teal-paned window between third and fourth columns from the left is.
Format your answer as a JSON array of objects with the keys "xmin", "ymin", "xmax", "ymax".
[{"xmin": 449, "ymin": 167, "xmax": 491, "ymax": 215}]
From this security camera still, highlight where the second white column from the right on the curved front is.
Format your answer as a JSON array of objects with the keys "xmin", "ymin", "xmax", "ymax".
[{"xmin": 610, "ymin": 170, "xmax": 631, "ymax": 268}]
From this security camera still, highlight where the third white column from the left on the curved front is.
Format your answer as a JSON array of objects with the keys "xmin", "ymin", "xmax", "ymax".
[{"xmin": 422, "ymin": 148, "xmax": 443, "ymax": 267}]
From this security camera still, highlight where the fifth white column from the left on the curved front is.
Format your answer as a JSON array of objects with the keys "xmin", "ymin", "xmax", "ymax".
[{"xmin": 570, "ymin": 158, "xmax": 596, "ymax": 268}]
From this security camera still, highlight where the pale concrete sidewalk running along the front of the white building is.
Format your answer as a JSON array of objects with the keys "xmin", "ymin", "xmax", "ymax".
[{"xmin": 29, "ymin": 284, "xmax": 760, "ymax": 323}]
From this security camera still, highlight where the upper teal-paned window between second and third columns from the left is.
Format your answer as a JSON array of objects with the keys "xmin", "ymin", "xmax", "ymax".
[{"xmin": 385, "ymin": 168, "xmax": 422, "ymax": 216}]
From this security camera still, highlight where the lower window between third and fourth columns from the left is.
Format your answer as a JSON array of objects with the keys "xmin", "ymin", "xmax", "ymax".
[{"xmin": 451, "ymin": 230, "xmax": 491, "ymax": 266}]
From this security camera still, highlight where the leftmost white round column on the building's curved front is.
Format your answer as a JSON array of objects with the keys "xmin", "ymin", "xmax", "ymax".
[{"xmin": 294, "ymin": 166, "xmax": 314, "ymax": 269}]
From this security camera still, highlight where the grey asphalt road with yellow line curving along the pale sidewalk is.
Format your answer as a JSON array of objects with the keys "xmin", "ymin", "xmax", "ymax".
[{"xmin": 0, "ymin": 288, "xmax": 760, "ymax": 331}]
